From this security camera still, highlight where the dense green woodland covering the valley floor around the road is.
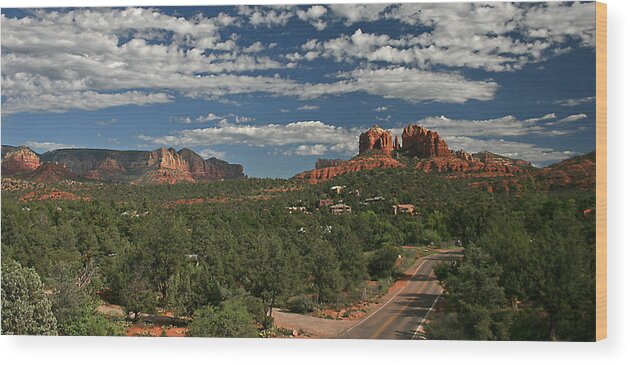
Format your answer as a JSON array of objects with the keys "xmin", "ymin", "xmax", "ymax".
[{"xmin": 2, "ymin": 169, "xmax": 594, "ymax": 339}]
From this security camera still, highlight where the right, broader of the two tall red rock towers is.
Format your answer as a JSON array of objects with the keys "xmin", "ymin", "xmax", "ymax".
[{"xmin": 402, "ymin": 124, "xmax": 451, "ymax": 158}]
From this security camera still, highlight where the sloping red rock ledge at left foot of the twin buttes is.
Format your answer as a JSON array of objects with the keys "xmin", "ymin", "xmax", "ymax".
[{"xmin": 294, "ymin": 155, "xmax": 403, "ymax": 184}]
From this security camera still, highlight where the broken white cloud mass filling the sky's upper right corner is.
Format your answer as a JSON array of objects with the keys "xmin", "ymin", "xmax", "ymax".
[{"xmin": 294, "ymin": 2, "xmax": 595, "ymax": 72}]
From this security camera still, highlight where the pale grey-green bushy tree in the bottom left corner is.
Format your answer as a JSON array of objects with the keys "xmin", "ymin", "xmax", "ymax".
[{"xmin": 2, "ymin": 259, "xmax": 57, "ymax": 335}]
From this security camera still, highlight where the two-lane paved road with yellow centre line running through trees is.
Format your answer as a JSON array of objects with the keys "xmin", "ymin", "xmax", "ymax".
[{"xmin": 339, "ymin": 251, "xmax": 460, "ymax": 340}]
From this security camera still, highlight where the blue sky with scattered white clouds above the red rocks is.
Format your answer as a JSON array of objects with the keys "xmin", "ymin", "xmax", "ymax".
[{"xmin": 1, "ymin": 3, "xmax": 595, "ymax": 177}]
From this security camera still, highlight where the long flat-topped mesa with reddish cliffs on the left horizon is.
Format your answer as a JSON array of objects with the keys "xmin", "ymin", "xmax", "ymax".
[{"xmin": 2, "ymin": 146, "xmax": 244, "ymax": 184}]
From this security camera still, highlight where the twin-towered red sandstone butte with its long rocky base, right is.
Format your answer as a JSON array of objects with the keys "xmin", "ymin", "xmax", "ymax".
[{"xmin": 294, "ymin": 125, "xmax": 595, "ymax": 191}]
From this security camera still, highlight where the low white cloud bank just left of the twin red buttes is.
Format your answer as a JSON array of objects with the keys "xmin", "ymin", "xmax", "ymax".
[{"xmin": 139, "ymin": 121, "xmax": 361, "ymax": 153}]
